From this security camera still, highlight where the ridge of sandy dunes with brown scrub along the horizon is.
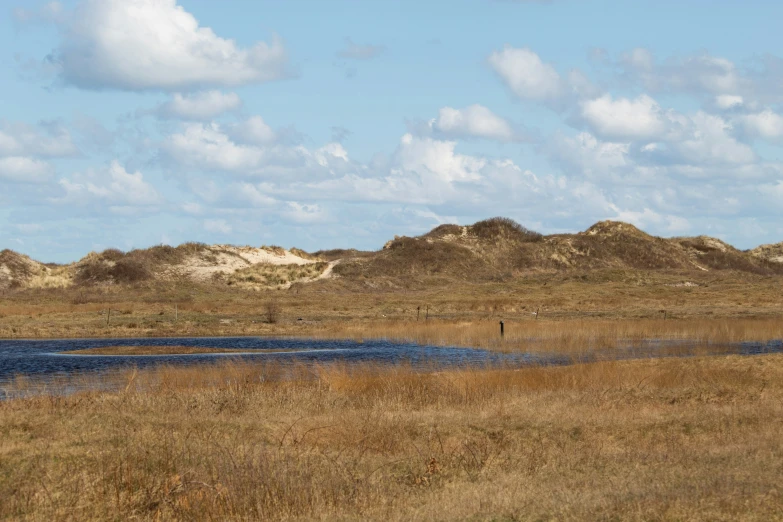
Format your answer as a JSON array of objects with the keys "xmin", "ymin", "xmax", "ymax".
[{"xmin": 6, "ymin": 218, "xmax": 783, "ymax": 288}]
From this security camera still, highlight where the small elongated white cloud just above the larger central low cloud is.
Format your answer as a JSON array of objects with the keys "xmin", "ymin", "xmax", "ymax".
[{"xmin": 430, "ymin": 105, "xmax": 514, "ymax": 141}]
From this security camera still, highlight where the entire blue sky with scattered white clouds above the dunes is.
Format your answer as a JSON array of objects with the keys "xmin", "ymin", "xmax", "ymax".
[{"xmin": 0, "ymin": 0, "xmax": 783, "ymax": 262}]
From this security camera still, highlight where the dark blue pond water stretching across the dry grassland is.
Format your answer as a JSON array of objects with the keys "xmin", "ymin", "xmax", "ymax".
[{"xmin": 0, "ymin": 337, "xmax": 783, "ymax": 399}]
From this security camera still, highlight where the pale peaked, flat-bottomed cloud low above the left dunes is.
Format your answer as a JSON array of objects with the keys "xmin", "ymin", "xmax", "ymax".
[{"xmin": 58, "ymin": 161, "xmax": 163, "ymax": 208}]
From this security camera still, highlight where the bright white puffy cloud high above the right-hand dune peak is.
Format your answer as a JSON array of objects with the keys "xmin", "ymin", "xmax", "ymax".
[{"xmin": 582, "ymin": 94, "xmax": 666, "ymax": 140}]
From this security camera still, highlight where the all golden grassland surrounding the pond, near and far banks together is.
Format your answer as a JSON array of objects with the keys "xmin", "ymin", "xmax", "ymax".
[{"xmin": 0, "ymin": 271, "xmax": 783, "ymax": 521}]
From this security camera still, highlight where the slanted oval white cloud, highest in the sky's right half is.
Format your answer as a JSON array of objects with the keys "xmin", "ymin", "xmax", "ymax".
[{"xmin": 489, "ymin": 45, "xmax": 563, "ymax": 100}]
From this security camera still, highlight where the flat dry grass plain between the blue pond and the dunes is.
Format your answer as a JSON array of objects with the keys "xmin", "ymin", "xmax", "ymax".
[{"xmin": 0, "ymin": 265, "xmax": 783, "ymax": 339}]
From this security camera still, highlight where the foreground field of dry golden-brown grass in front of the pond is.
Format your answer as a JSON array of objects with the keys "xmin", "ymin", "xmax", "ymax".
[{"xmin": 0, "ymin": 355, "xmax": 783, "ymax": 521}]
